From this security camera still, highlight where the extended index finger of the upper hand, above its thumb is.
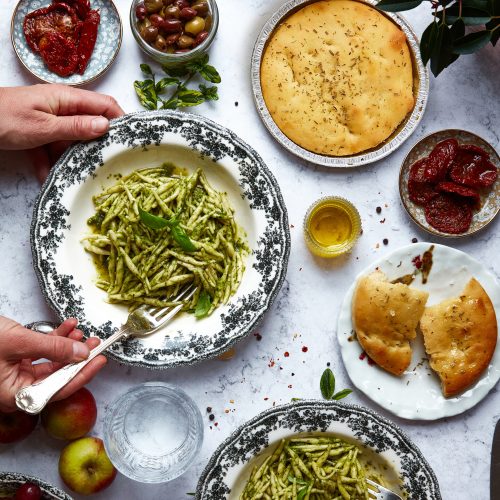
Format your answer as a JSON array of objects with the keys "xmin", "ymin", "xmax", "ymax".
[{"xmin": 55, "ymin": 85, "xmax": 125, "ymax": 120}]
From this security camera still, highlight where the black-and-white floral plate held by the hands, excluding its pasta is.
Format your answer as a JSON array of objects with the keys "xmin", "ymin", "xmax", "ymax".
[{"xmin": 31, "ymin": 111, "xmax": 290, "ymax": 368}]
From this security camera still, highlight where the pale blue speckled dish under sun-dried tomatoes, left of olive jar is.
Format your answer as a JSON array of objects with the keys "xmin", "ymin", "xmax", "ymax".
[{"xmin": 10, "ymin": 0, "xmax": 123, "ymax": 86}]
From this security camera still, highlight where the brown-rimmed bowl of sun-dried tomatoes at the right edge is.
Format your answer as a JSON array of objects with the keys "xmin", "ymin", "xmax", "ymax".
[{"xmin": 399, "ymin": 129, "xmax": 500, "ymax": 237}]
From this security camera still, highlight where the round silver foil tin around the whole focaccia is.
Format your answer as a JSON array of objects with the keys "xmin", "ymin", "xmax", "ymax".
[{"xmin": 251, "ymin": 0, "xmax": 429, "ymax": 168}]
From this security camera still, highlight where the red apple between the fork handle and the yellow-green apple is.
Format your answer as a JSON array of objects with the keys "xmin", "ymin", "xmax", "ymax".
[{"xmin": 42, "ymin": 387, "xmax": 97, "ymax": 440}]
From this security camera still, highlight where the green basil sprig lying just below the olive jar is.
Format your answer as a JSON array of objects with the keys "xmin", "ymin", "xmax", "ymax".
[{"xmin": 134, "ymin": 54, "xmax": 221, "ymax": 110}]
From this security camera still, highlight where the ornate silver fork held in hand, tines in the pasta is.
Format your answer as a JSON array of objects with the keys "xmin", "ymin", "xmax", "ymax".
[{"xmin": 16, "ymin": 285, "xmax": 196, "ymax": 415}]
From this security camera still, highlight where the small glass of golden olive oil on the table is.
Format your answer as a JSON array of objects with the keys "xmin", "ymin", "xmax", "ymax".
[{"xmin": 304, "ymin": 196, "xmax": 361, "ymax": 257}]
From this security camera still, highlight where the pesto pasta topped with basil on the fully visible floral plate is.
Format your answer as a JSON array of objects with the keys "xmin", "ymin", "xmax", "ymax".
[{"xmin": 82, "ymin": 163, "xmax": 248, "ymax": 317}]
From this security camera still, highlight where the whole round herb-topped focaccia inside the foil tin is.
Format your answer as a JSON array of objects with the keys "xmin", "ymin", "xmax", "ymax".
[{"xmin": 260, "ymin": 0, "xmax": 415, "ymax": 156}]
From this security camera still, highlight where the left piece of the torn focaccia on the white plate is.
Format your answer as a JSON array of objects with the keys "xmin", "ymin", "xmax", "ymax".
[{"xmin": 352, "ymin": 271, "xmax": 429, "ymax": 375}]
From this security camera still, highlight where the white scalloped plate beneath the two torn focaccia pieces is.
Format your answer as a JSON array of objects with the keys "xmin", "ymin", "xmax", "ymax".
[{"xmin": 337, "ymin": 243, "xmax": 500, "ymax": 420}]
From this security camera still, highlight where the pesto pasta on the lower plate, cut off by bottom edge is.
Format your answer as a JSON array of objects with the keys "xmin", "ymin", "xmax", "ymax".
[{"xmin": 240, "ymin": 436, "xmax": 383, "ymax": 500}]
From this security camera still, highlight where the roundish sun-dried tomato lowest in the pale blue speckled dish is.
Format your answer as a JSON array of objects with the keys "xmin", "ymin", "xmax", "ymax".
[{"xmin": 39, "ymin": 32, "xmax": 78, "ymax": 76}]
